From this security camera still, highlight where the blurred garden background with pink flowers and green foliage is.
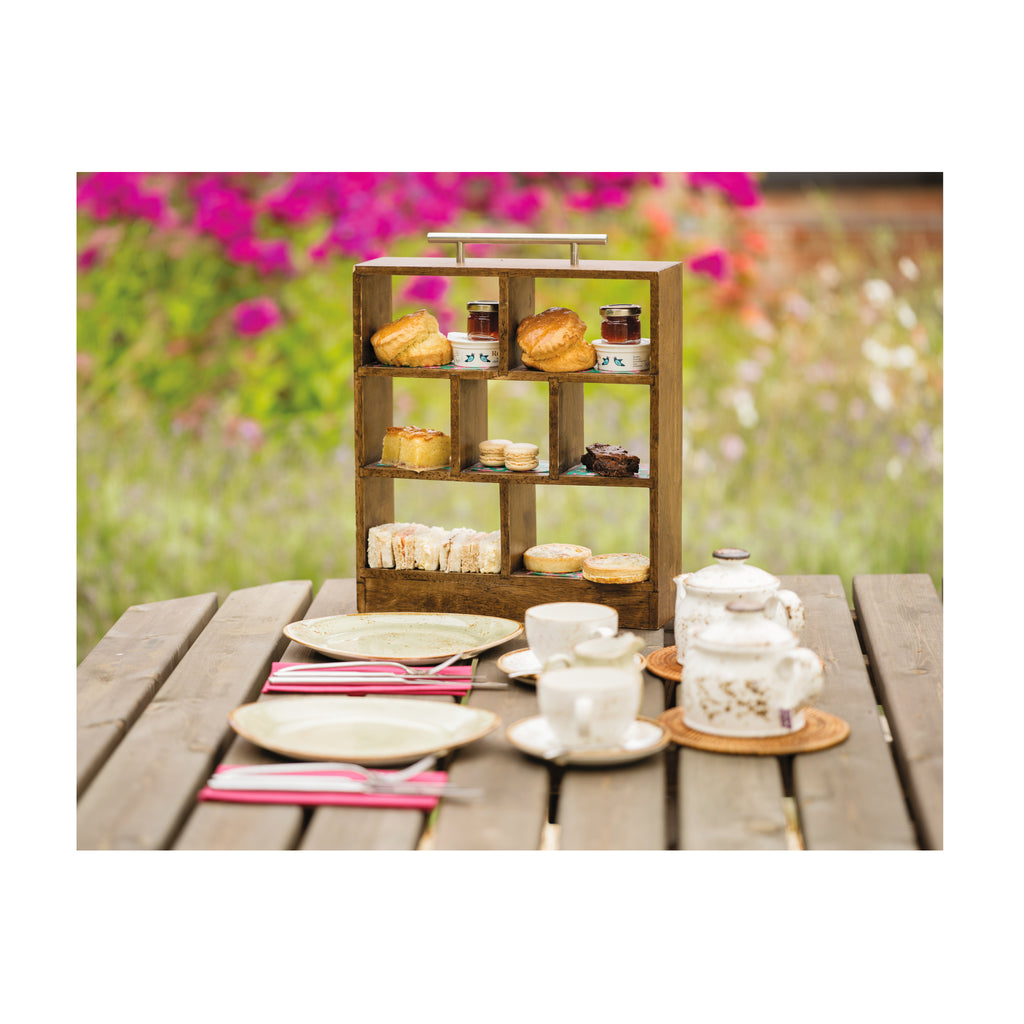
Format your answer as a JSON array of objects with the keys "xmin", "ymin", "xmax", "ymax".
[{"xmin": 77, "ymin": 172, "xmax": 942, "ymax": 659}]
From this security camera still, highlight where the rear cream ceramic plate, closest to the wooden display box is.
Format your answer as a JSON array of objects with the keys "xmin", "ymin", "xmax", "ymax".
[{"xmin": 285, "ymin": 611, "xmax": 523, "ymax": 665}]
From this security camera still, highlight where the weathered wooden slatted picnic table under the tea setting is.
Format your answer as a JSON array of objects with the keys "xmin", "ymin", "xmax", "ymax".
[{"xmin": 78, "ymin": 574, "xmax": 942, "ymax": 851}]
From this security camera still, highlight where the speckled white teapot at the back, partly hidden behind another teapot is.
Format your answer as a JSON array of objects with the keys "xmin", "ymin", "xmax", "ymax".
[{"xmin": 675, "ymin": 548, "xmax": 804, "ymax": 665}]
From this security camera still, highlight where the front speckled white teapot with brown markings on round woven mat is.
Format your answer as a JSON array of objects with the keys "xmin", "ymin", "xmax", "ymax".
[{"xmin": 681, "ymin": 601, "xmax": 824, "ymax": 737}]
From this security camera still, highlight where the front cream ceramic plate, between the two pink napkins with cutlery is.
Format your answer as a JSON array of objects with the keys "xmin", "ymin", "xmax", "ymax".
[{"xmin": 228, "ymin": 695, "xmax": 500, "ymax": 765}]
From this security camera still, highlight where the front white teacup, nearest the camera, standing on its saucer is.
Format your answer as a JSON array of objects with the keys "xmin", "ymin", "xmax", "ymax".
[{"xmin": 537, "ymin": 668, "xmax": 641, "ymax": 751}]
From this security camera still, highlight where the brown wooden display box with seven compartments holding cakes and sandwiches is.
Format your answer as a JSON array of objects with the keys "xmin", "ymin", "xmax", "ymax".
[{"xmin": 352, "ymin": 251, "xmax": 682, "ymax": 629}]
